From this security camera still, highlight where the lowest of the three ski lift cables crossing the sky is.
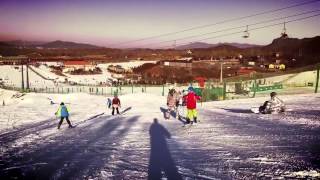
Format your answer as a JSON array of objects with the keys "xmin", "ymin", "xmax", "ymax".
[{"xmin": 158, "ymin": 13, "xmax": 320, "ymax": 49}]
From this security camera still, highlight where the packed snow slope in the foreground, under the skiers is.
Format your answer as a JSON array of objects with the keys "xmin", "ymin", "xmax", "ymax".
[{"xmin": 0, "ymin": 90, "xmax": 320, "ymax": 179}]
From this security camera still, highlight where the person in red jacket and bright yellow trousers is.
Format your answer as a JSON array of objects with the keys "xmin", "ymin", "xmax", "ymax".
[{"xmin": 183, "ymin": 87, "xmax": 201, "ymax": 124}]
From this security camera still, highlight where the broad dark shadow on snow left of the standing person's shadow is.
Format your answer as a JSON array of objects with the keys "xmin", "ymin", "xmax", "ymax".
[{"xmin": 0, "ymin": 116, "xmax": 138, "ymax": 179}]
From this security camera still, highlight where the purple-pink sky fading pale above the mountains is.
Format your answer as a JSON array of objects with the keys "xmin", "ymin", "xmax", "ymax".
[{"xmin": 0, "ymin": 0, "xmax": 320, "ymax": 48}]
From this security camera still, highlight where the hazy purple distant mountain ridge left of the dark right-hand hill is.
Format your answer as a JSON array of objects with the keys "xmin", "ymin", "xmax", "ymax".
[{"xmin": 176, "ymin": 42, "xmax": 261, "ymax": 50}]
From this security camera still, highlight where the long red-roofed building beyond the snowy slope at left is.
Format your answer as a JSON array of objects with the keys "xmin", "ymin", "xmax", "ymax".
[{"xmin": 63, "ymin": 60, "xmax": 96, "ymax": 72}]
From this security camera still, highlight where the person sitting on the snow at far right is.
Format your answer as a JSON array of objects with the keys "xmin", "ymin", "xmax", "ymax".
[{"xmin": 259, "ymin": 92, "xmax": 285, "ymax": 114}]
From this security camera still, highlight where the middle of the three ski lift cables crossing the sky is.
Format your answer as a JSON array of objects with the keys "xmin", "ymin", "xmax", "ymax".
[{"xmin": 134, "ymin": 9, "xmax": 320, "ymax": 47}]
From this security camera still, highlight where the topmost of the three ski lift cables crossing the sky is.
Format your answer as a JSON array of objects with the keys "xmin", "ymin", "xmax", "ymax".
[{"xmin": 109, "ymin": 0, "xmax": 320, "ymax": 46}]
